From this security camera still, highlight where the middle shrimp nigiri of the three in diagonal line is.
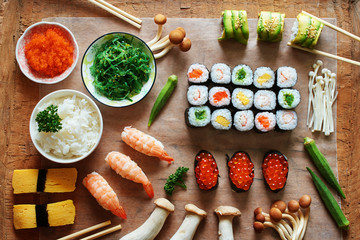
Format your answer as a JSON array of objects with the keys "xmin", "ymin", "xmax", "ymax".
[{"xmin": 105, "ymin": 151, "xmax": 154, "ymax": 198}]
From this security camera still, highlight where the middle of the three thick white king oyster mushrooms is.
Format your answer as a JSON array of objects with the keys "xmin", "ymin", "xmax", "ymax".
[{"xmin": 170, "ymin": 204, "xmax": 206, "ymax": 240}]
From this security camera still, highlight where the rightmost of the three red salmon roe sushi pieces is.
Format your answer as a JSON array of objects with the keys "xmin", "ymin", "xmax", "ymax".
[{"xmin": 262, "ymin": 151, "xmax": 289, "ymax": 192}]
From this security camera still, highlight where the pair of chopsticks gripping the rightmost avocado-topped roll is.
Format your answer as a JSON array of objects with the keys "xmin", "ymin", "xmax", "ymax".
[{"xmin": 288, "ymin": 11, "xmax": 360, "ymax": 66}]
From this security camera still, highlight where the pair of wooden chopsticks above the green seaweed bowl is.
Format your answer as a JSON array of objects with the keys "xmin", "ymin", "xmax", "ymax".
[{"xmin": 88, "ymin": 0, "xmax": 142, "ymax": 29}]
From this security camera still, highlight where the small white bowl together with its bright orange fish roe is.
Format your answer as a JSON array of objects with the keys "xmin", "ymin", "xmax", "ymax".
[{"xmin": 15, "ymin": 22, "xmax": 79, "ymax": 84}]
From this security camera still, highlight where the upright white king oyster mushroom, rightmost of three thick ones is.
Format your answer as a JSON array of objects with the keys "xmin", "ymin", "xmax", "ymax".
[{"xmin": 215, "ymin": 206, "xmax": 241, "ymax": 240}]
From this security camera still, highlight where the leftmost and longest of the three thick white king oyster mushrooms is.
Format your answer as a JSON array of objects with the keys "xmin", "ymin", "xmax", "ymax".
[{"xmin": 120, "ymin": 198, "xmax": 175, "ymax": 240}]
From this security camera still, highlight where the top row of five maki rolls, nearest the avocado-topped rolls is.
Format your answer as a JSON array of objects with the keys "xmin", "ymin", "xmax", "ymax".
[{"xmin": 187, "ymin": 63, "xmax": 297, "ymax": 89}]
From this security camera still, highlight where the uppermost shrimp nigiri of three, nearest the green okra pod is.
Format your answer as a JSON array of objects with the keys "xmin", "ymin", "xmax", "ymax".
[{"xmin": 121, "ymin": 127, "xmax": 174, "ymax": 163}]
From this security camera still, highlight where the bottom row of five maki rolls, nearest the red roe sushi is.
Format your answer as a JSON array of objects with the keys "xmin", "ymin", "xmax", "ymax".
[{"xmin": 185, "ymin": 106, "xmax": 298, "ymax": 133}]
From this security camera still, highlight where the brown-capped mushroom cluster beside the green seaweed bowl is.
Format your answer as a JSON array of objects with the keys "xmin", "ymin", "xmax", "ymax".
[{"xmin": 147, "ymin": 14, "xmax": 191, "ymax": 59}]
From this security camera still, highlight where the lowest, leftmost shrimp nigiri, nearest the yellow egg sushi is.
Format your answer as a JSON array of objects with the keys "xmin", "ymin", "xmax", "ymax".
[{"xmin": 83, "ymin": 172, "xmax": 126, "ymax": 219}]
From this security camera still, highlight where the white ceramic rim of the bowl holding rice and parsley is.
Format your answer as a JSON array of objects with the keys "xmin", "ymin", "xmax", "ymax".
[{"xmin": 30, "ymin": 89, "xmax": 103, "ymax": 163}]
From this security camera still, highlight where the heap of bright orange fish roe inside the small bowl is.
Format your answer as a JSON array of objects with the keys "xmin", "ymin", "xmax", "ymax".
[{"xmin": 25, "ymin": 27, "xmax": 74, "ymax": 77}]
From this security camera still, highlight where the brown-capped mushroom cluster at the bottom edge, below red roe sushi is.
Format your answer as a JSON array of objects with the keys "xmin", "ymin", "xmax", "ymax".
[{"xmin": 253, "ymin": 195, "xmax": 311, "ymax": 240}]
